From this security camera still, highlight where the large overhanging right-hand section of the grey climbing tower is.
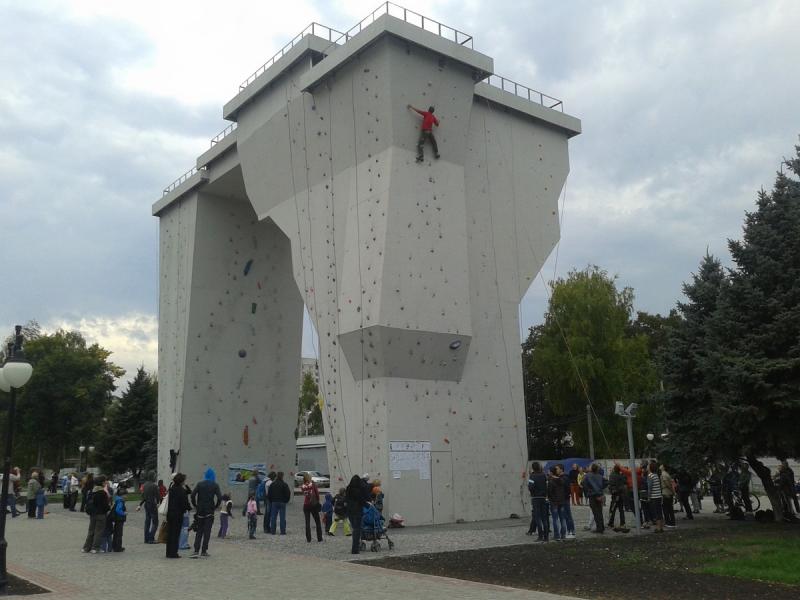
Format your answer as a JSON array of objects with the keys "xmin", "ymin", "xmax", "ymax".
[{"xmin": 156, "ymin": 4, "xmax": 580, "ymax": 523}]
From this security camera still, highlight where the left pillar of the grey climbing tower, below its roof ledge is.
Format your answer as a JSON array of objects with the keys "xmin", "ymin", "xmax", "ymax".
[{"xmin": 159, "ymin": 193, "xmax": 302, "ymax": 500}]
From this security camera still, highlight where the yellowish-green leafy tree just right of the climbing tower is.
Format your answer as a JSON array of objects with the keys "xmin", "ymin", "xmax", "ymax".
[{"xmin": 532, "ymin": 267, "xmax": 656, "ymax": 454}]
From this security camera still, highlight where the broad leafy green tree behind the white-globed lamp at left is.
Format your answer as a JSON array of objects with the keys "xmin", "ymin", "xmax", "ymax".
[{"xmin": 5, "ymin": 330, "xmax": 125, "ymax": 468}]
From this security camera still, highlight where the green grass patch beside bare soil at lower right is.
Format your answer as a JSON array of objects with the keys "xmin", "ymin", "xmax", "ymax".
[{"xmin": 699, "ymin": 535, "xmax": 800, "ymax": 585}]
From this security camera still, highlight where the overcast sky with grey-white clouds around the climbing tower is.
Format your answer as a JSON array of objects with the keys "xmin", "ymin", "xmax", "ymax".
[{"xmin": 0, "ymin": 0, "xmax": 800, "ymax": 382}]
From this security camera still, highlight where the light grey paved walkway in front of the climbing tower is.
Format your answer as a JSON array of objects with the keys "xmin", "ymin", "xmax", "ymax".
[{"xmin": 7, "ymin": 503, "xmax": 580, "ymax": 600}]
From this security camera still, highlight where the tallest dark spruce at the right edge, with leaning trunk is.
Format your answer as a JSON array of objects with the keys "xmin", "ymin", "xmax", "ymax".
[{"xmin": 713, "ymin": 146, "xmax": 800, "ymax": 516}]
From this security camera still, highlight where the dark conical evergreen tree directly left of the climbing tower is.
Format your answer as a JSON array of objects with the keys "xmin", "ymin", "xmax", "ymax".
[{"xmin": 96, "ymin": 367, "xmax": 158, "ymax": 479}]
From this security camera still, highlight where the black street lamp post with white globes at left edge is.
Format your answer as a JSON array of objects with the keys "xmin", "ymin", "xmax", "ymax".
[{"xmin": 0, "ymin": 325, "xmax": 33, "ymax": 592}]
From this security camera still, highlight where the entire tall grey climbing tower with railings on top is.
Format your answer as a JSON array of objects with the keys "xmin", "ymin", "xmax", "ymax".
[{"xmin": 153, "ymin": 3, "xmax": 580, "ymax": 524}]
